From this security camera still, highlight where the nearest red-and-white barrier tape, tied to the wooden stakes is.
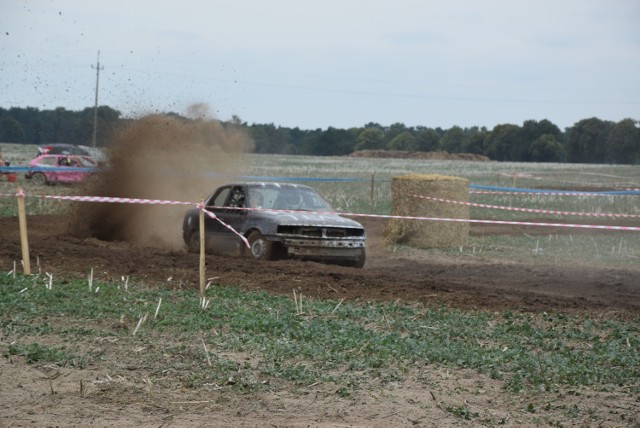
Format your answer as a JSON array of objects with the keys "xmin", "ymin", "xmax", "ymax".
[{"xmin": 1, "ymin": 195, "xmax": 640, "ymax": 232}]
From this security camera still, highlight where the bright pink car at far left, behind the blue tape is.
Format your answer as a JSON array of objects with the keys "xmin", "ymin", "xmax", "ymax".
[{"xmin": 24, "ymin": 154, "xmax": 98, "ymax": 185}]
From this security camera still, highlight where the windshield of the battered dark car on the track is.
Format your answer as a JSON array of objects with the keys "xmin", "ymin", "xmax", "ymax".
[{"xmin": 249, "ymin": 186, "xmax": 333, "ymax": 212}]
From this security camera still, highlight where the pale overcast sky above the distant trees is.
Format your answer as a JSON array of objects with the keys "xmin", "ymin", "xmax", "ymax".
[{"xmin": 0, "ymin": 0, "xmax": 640, "ymax": 129}]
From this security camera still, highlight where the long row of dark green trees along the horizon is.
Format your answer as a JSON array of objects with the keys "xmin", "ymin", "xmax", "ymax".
[{"xmin": 0, "ymin": 106, "xmax": 640, "ymax": 164}]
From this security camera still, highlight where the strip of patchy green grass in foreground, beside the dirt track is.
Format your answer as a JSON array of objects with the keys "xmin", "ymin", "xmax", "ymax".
[{"xmin": 0, "ymin": 274, "xmax": 640, "ymax": 396}]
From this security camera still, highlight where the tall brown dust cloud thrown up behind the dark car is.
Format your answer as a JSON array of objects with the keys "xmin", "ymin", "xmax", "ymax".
[{"xmin": 72, "ymin": 104, "xmax": 253, "ymax": 250}]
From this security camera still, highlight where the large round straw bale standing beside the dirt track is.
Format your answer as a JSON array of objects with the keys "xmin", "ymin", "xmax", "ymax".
[{"xmin": 384, "ymin": 174, "xmax": 469, "ymax": 248}]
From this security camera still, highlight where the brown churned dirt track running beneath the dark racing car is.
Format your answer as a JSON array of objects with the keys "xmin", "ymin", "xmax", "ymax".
[{"xmin": 0, "ymin": 216, "xmax": 640, "ymax": 314}]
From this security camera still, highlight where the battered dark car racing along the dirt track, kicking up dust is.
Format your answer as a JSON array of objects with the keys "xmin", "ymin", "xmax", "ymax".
[{"xmin": 183, "ymin": 183, "xmax": 366, "ymax": 268}]
